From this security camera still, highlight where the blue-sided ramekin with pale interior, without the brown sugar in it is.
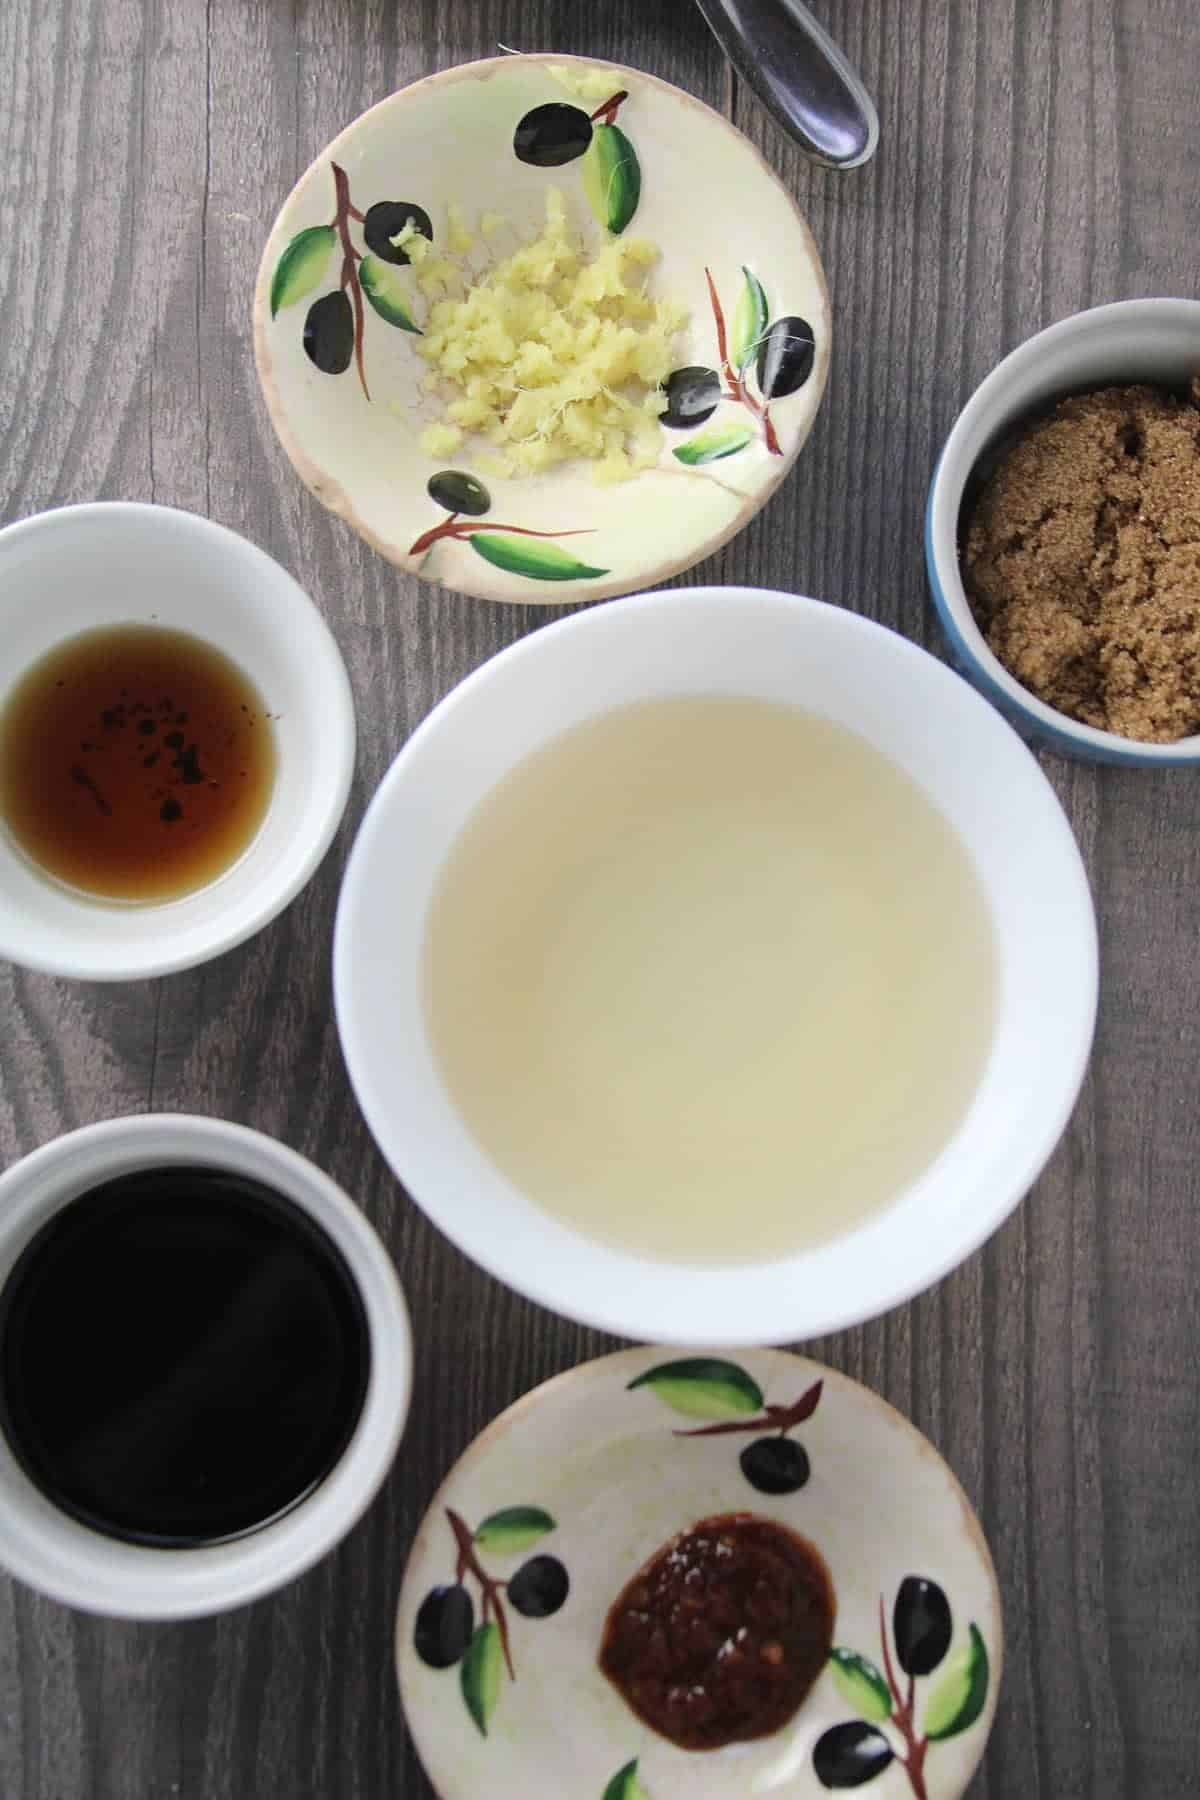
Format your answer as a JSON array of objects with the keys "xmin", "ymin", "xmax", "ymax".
[{"xmin": 925, "ymin": 301, "xmax": 1200, "ymax": 769}]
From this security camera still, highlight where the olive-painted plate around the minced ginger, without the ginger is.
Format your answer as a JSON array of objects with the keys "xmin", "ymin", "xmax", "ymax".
[{"xmin": 254, "ymin": 56, "xmax": 829, "ymax": 601}]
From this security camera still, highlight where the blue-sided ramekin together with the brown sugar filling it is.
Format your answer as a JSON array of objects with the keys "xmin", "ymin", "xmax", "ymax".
[{"xmin": 925, "ymin": 299, "xmax": 1200, "ymax": 767}]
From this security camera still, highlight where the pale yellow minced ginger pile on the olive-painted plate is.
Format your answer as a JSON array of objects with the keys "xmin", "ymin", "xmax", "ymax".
[{"xmin": 396, "ymin": 187, "xmax": 687, "ymax": 482}]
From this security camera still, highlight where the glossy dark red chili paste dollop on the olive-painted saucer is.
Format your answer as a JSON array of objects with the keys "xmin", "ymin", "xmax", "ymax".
[{"xmin": 599, "ymin": 1512, "xmax": 835, "ymax": 1750}]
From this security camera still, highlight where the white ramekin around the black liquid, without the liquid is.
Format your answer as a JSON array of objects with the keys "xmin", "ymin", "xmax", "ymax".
[{"xmin": 0, "ymin": 1112, "xmax": 412, "ymax": 1618}]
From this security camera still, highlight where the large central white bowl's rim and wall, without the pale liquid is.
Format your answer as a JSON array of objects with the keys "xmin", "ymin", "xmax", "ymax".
[{"xmin": 335, "ymin": 589, "xmax": 1097, "ymax": 1345}]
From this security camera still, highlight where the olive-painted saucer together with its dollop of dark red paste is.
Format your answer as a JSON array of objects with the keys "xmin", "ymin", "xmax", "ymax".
[{"xmin": 396, "ymin": 1348, "xmax": 1002, "ymax": 1800}]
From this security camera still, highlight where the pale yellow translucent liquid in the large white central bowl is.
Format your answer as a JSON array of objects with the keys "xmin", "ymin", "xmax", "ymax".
[{"xmin": 425, "ymin": 697, "xmax": 997, "ymax": 1264}]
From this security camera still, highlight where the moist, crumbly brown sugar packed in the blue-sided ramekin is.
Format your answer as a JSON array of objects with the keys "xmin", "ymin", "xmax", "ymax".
[{"xmin": 963, "ymin": 382, "xmax": 1200, "ymax": 743}]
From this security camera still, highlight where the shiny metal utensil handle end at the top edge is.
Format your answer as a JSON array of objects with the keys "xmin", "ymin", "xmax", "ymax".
[{"xmin": 696, "ymin": 0, "xmax": 880, "ymax": 169}]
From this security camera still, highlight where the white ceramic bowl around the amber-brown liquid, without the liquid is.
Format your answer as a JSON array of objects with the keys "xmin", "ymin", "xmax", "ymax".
[{"xmin": 0, "ymin": 502, "xmax": 354, "ymax": 981}]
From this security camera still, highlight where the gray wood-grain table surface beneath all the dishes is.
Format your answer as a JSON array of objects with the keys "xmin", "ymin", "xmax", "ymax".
[{"xmin": 0, "ymin": 0, "xmax": 1200, "ymax": 1800}]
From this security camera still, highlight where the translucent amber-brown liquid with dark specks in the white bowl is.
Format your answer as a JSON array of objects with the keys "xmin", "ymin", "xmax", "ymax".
[{"xmin": 0, "ymin": 625, "xmax": 275, "ymax": 900}]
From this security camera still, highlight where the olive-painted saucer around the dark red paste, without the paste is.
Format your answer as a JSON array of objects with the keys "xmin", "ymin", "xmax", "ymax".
[{"xmin": 396, "ymin": 1348, "xmax": 1002, "ymax": 1800}]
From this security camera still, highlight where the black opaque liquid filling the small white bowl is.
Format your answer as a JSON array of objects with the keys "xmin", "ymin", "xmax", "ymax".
[{"xmin": 0, "ymin": 1168, "xmax": 371, "ymax": 1546}]
